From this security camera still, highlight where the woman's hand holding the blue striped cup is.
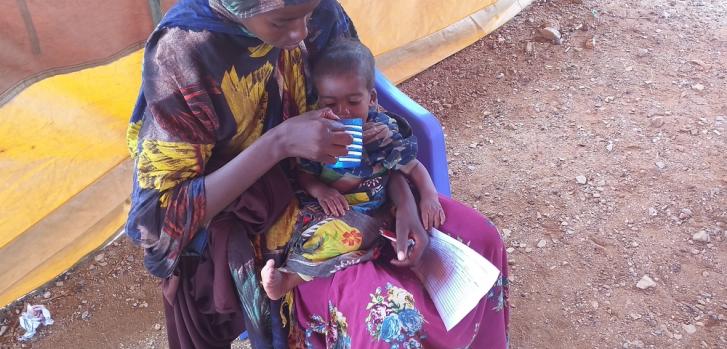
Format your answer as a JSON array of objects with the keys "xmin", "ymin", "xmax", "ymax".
[{"xmin": 271, "ymin": 108, "xmax": 353, "ymax": 163}]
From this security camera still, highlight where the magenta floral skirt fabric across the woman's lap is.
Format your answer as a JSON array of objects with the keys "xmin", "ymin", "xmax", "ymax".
[{"xmin": 292, "ymin": 197, "xmax": 508, "ymax": 349}]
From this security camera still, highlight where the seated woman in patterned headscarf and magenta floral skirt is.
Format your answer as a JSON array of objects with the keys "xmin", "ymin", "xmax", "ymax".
[{"xmin": 126, "ymin": 0, "xmax": 507, "ymax": 348}]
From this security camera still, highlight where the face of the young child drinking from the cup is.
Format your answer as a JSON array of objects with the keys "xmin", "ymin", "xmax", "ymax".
[{"xmin": 316, "ymin": 73, "xmax": 376, "ymax": 120}]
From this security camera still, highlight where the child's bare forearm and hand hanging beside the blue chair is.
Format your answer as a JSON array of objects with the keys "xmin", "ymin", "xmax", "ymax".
[{"xmin": 401, "ymin": 159, "xmax": 447, "ymax": 230}]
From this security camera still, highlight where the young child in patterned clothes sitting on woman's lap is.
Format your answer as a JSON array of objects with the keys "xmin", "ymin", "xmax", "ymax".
[{"xmin": 262, "ymin": 40, "xmax": 445, "ymax": 299}]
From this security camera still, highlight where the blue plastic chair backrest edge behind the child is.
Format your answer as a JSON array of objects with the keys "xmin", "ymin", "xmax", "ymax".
[{"xmin": 376, "ymin": 71, "xmax": 452, "ymax": 196}]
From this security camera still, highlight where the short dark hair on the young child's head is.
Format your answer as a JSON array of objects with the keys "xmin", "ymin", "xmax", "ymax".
[{"xmin": 313, "ymin": 39, "xmax": 376, "ymax": 89}]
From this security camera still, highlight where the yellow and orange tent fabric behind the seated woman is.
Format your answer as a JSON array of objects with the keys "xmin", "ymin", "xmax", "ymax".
[{"xmin": 0, "ymin": 0, "xmax": 532, "ymax": 306}]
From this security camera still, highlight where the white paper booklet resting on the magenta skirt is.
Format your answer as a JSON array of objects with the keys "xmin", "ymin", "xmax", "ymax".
[{"xmin": 415, "ymin": 229, "xmax": 500, "ymax": 331}]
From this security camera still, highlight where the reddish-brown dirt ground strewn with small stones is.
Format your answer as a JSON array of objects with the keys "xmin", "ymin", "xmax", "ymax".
[{"xmin": 0, "ymin": 0, "xmax": 727, "ymax": 348}]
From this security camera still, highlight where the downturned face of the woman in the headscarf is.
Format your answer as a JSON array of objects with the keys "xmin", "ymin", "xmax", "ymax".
[{"xmin": 241, "ymin": 0, "xmax": 320, "ymax": 49}]
